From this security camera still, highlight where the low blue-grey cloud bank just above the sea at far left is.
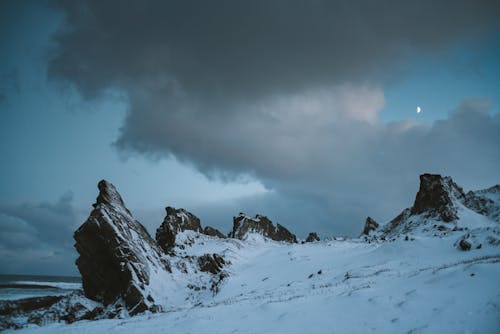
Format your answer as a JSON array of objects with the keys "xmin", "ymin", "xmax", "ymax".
[{"xmin": 0, "ymin": 193, "xmax": 76, "ymax": 274}]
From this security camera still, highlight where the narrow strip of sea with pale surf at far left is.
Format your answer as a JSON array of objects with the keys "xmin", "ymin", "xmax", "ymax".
[{"xmin": 0, "ymin": 275, "xmax": 82, "ymax": 301}]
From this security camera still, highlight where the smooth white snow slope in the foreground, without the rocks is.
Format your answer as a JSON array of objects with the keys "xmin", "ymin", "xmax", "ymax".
[{"xmin": 7, "ymin": 232, "xmax": 500, "ymax": 334}]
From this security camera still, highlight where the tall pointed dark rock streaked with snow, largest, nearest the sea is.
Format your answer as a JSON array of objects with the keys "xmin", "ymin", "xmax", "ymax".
[{"xmin": 74, "ymin": 180, "xmax": 170, "ymax": 315}]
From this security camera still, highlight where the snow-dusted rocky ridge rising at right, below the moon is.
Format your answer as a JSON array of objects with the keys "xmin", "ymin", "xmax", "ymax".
[{"xmin": 362, "ymin": 174, "xmax": 500, "ymax": 250}]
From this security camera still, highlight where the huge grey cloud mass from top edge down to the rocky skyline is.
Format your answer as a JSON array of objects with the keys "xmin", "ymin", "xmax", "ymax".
[{"xmin": 50, "ymin": 1, "xmax": 500, "ymax": 234}]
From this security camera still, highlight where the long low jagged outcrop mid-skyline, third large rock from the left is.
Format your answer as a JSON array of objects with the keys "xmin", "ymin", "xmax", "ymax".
[{"xmin": 229, "ymin": 213, "xmax": 297, "ymax": 243}]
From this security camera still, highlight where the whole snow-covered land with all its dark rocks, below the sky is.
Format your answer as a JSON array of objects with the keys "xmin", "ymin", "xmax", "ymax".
[{"xmin": 0, "ymin": 174, "xmax": 500, "ymax": 334}]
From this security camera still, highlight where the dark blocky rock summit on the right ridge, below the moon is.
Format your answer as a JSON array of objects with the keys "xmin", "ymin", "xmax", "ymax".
[{"xmin": 411, "ymin": 174, "xmax": 465, "ymax": 222}]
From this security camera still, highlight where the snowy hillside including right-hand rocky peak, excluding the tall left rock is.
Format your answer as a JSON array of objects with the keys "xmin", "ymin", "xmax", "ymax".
[{"xmin": 1, "ymin": 174, "xmax": 500, "ymax": 334}]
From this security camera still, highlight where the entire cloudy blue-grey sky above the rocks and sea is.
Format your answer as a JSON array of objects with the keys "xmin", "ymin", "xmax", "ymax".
[{"xmin": 0, "ymin": 0, "xmax": 500, "ymax": 275}]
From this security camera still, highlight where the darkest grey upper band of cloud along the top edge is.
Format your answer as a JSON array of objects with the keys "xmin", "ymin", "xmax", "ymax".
[{"xmin": 51, "ymin": 0, "xmax": 500, "ymax": 99}]
